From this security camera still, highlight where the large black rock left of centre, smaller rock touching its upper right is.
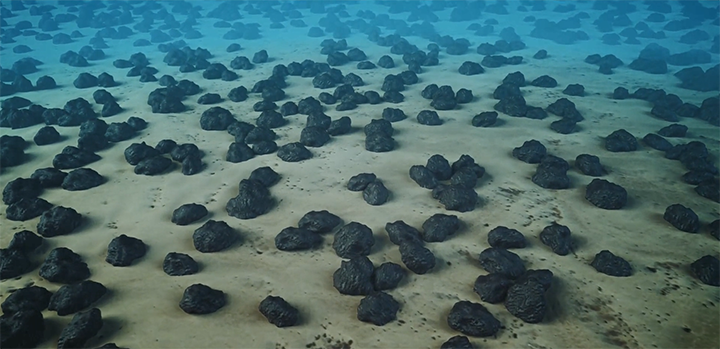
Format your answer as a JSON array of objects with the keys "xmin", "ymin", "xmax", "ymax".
[{"xmin": 225, "ymin": 179, "xmax": 274, "ymax": 219}]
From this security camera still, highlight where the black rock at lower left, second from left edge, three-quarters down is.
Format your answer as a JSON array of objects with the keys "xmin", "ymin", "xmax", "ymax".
[{"xmin": 40, "ymin": 247, "xmax": 90, "ymax": 284}]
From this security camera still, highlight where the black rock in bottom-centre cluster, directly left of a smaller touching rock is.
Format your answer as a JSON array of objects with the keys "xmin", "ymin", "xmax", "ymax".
[{"xmin": 333, "ymin": 256, "xmax": 374, "ymax": 296}]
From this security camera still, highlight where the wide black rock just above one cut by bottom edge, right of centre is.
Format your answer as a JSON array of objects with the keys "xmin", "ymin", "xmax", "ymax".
[{"xmin": 447, "ymin": 301, "xmax": 500, "ymax": 337}]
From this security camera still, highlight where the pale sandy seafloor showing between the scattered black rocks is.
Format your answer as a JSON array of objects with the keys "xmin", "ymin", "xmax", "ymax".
[{"xmin": 0, "ymin": 1, "xmax": 720, "ymax": 349}]
